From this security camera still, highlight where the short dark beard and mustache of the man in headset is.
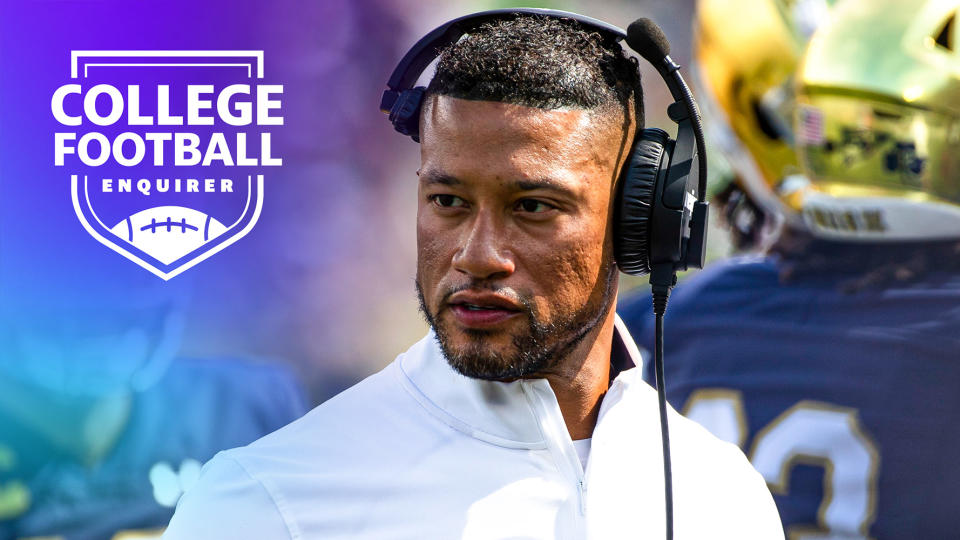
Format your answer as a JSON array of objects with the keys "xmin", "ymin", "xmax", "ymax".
[{"xmin": 416, "ymin": 265, "xmax": 617, "ymax": 381}]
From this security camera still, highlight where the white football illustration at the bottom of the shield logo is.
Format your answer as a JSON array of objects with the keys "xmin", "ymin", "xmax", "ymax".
[{"xmin": 110, "ymin": 206, "xmax": 227, "ymax": 264}]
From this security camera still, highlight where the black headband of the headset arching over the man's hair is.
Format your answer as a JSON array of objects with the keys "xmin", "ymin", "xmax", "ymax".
[{"xmin": 380, "ymin": 8, "xmax": 707, "ymax": 202}]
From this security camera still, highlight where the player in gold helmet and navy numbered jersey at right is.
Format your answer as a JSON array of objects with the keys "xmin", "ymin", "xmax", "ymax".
[{"xmin": 621, "ymin": 0, "xmax": 960, "ymax": 538}]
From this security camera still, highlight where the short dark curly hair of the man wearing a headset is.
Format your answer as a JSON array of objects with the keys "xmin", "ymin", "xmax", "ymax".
[{"xmin": 427, "ymin": 15, "xmax": 643, "ymax": 129}]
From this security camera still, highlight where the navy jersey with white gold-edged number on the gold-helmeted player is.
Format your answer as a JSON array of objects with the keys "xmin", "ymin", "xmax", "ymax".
[{"xmin": 619, "ymin": 257, "xmax": 960, "ymax": 539}]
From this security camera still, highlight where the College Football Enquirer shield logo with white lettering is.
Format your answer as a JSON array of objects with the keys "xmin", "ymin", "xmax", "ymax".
[{"xmin": 54, "ymin": 51, "xmax": 283, "ymax": 280}]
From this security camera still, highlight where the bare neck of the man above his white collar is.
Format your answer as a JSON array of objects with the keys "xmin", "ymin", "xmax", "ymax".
[{"xmin": 545, "ymin": 309, "xmax": 615, "ymax": 441}]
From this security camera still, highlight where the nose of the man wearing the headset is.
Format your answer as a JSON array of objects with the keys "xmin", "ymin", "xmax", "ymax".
[{"xmin": 453, "ymin": 210, "xmax": 516, "ymax": 280}]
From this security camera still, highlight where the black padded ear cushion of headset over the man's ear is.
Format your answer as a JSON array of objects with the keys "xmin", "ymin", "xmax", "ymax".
[{"xmin": 614, "ymin": 128, "xmax": 668, "ymax": 276}]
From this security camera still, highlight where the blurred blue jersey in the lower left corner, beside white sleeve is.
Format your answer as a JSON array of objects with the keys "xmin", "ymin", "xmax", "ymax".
[{"xmin": 0, "ymin": 359, "xmax": 306, "ymax": 540}]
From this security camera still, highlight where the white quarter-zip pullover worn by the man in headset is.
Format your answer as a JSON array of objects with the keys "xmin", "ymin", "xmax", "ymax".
[{"xmin": 163, "ymin": 319, "xmax": 783, "ymax": 540}]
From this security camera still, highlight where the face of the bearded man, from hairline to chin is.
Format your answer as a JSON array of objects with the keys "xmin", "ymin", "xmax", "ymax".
[{"xmin": 417, "ymin": 96, "xmax": 632, "ymax": 379}]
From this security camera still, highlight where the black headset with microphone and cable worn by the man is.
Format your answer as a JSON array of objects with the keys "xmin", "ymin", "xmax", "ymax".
[{"xmin": 380, "ymin": 8, "xmax": 709, "ymax": 540}]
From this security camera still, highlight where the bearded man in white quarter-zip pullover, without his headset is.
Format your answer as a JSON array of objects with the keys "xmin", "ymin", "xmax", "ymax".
[{"xmin": 165, "ymin": 16, "xmax": 781, "ymax": 539}]
